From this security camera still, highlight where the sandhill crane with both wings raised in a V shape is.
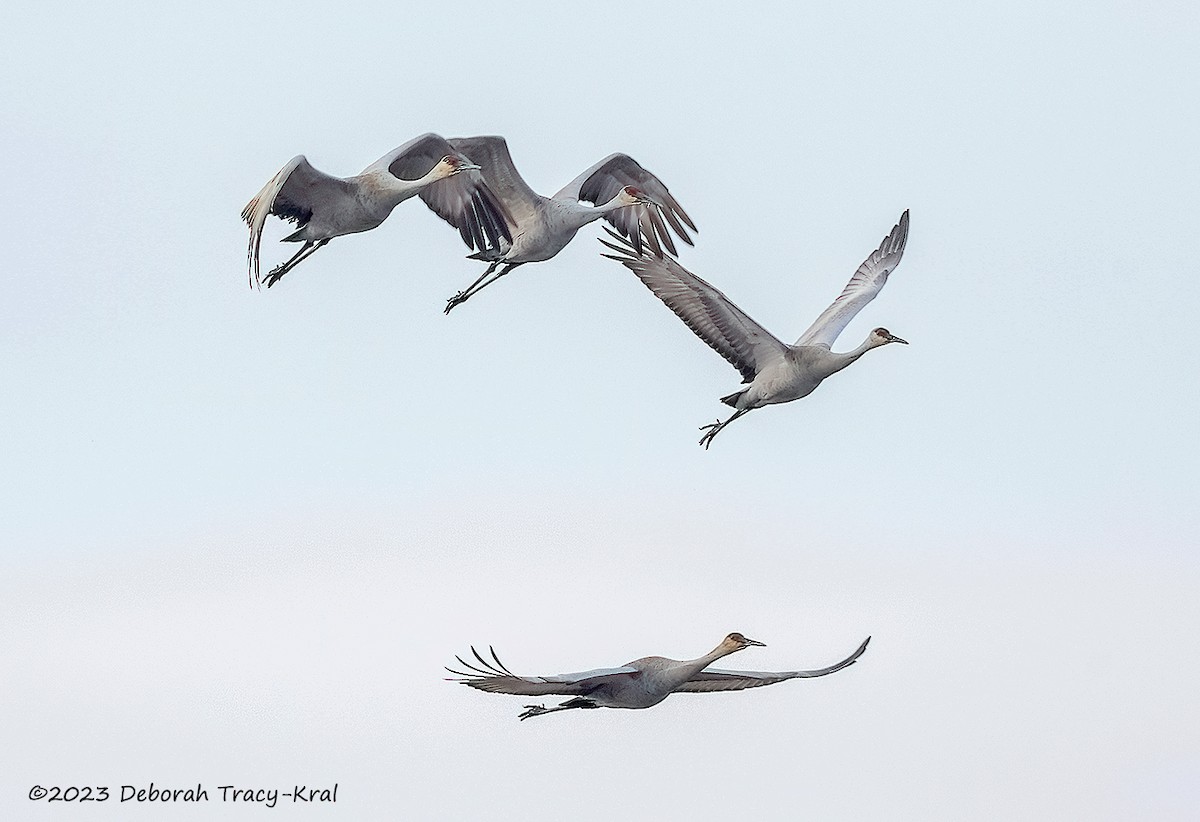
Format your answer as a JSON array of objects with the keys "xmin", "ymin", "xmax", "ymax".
[{"xmin": 600, "ymin": 211, "xmax": 908, "ymax": 449}]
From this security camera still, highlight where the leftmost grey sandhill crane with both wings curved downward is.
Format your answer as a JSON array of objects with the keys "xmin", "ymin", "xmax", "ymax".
[{"xmin": 241, "ymin": 134, "xmax": 512, "ymax": 288}]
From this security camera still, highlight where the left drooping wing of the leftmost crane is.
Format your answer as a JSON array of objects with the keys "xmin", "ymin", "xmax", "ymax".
[{"xmin": 241, "ymin": 155, "xmax": 356, "ymax": 288}]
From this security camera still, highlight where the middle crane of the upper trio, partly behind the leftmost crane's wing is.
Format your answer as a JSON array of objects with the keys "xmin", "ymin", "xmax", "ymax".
[{"xmin": 445, "ymin": 137, "xmax": 696, "ymax": 313}]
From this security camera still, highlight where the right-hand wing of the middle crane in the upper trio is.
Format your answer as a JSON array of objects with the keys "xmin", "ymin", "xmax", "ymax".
[{"xmin": 554, "ymin": 154, "xmax": 696, "ymax": 257}]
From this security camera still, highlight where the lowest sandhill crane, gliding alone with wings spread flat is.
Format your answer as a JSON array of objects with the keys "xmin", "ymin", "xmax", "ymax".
[{"xmin": 446, "ymin": 634, "xmax": 871, "ymax": 720}]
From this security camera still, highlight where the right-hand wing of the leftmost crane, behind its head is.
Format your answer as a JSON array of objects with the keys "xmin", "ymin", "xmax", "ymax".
[{"xmin": 368, "ymin": 133, "xmax": 512, "ymax": 251}]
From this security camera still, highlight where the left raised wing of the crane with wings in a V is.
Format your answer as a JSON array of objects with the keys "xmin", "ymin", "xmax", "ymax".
[{"xmin": 600, "ymin": 229, "xmax": 787, "ymax": 383}]
